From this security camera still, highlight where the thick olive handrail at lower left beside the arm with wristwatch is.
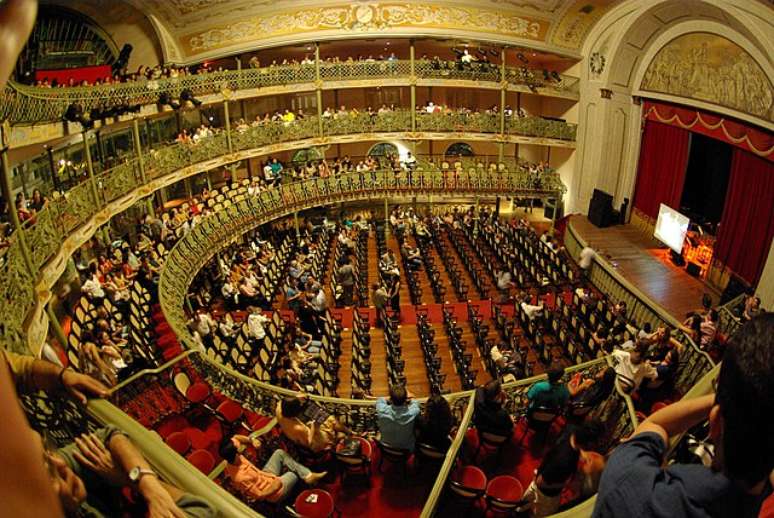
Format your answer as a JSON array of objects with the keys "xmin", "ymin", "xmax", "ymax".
[{"xmin": 87, "ymin": 399, "xmax": 261, "ymax": 516}]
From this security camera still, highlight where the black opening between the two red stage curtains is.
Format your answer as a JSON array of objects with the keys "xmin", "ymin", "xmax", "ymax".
[{"xmin": 680, "ymin": 133, "xmax": 733, "ymax": 226}]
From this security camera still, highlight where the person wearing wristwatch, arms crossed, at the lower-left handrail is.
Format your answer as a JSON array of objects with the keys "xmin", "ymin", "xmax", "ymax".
[{"xmin": 45, "ymin": 426, "xmax": 217, "ymax": 518}]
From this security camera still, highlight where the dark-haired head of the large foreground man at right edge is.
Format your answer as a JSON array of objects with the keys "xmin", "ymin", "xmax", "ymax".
[{"xmin": 709, "ymin": 314, "xmax": 774, "ymax": 488}]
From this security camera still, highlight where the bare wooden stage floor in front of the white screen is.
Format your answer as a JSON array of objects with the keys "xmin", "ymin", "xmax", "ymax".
[{"xmin": 570, "ymin": 215, "xmax": 720, "ymax": 322}]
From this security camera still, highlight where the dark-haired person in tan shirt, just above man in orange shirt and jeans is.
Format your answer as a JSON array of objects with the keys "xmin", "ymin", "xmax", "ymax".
[{"xmin": 275, "ymin": 395, "xmax": 351, "ymax": 453}]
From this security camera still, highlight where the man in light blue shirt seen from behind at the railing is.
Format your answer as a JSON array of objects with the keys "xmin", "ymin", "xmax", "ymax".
[{"xmin": 376, "ymin": 385, "xmax": 420, "ymax": 451}]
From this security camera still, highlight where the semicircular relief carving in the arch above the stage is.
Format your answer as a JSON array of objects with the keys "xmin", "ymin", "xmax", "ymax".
[{"xmin": 641, "ymin": 33, "xmax": 774, "ymax": 121}]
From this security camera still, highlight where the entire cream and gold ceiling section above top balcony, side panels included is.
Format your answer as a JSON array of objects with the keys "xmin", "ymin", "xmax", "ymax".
[{"xmin": 123, "ymin": 0, "xmax": 621, "ymax": 62}]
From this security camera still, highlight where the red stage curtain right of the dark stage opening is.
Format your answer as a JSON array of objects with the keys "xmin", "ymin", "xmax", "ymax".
[{"xmin": 715, "ymin": 149, "xmax": 774, "ymax": 286}]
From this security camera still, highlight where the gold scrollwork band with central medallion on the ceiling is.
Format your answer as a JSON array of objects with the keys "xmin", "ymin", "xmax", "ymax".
[{"xmin": 181, "ymin": 2, "xmax": 548, "ymax": 52}]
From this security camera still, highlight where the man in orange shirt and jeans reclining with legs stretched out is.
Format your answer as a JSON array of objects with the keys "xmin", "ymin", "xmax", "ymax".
[{"xmin": 220, "ymin": 435, "xmax": 328, "ymax": 503}]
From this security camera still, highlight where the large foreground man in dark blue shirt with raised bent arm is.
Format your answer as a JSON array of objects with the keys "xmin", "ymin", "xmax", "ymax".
[{"xmin": 593, "ymin": 313, "xmax": 774, "ymax": 518}]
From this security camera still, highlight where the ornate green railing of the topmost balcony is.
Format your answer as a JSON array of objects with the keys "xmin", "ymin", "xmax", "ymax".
[{"xmin": 0, "ymin": 60, "xmax": 578, "ymax": 124}]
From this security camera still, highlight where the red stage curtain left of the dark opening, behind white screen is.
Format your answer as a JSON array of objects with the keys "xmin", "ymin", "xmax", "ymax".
[{"xmin": 633, "ymin": 120, "xmax": 690, "ymax": 219}]
